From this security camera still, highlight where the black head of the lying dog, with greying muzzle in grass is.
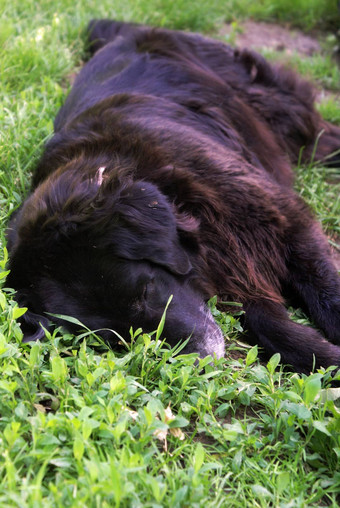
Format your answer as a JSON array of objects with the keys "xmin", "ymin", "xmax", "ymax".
[{"xmin": 8, "ymin": 167, "xmax": 224, "ymax": 357}]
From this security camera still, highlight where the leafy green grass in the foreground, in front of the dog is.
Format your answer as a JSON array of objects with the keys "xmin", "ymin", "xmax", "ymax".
[{"xmin": 0, "ymin": 288, "xmax": 340, "ymax": 507}]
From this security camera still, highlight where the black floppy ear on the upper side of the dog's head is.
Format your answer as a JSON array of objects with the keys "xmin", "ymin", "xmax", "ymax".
[{"xmin": 98, "ymin": 182, "xmax": 192, "ymax": 275}]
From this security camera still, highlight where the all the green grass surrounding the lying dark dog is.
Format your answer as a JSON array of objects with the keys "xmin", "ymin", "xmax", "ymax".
[{"xmin": 0, "ymin": 0, "xmax": 340, "ymax": 508}]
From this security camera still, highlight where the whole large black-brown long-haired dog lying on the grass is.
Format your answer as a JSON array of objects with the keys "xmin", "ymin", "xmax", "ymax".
[{"xmin": 8, "ymin": 20, "xmax": 340, "ymax": 371}]
